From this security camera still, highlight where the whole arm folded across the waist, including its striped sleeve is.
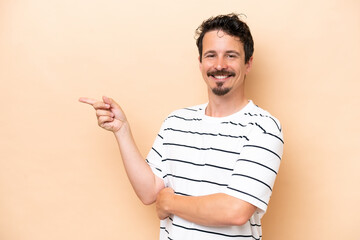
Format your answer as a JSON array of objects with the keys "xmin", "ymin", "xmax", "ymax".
[{"xmin": 156, "ymin": 119, "xmax": 284, "ymax": 226}]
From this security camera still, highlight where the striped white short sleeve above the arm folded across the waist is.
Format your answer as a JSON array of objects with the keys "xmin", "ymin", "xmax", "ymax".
[{"xmin": 225, "ymin": 128, "xmax": 284, "ymax": 215}]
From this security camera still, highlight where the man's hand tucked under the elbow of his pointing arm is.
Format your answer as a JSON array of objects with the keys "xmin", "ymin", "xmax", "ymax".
[{"xmin": 156, "ymin": 188, "xmax": 175, "ymax": 220}]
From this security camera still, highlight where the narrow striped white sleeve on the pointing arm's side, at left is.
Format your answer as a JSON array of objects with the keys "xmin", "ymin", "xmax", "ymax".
[{"xmin": 146, "ymin": 123, "xmax": 167, "ymax": 186}]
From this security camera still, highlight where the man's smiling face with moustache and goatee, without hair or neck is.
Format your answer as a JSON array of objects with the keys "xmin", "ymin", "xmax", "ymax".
[{"xmin": 200, "ymin": 30, "xmax": 252, "ymax": 96}]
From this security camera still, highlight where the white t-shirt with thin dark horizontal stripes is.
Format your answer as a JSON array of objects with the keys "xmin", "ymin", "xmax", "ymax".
[{"xmin": 146, "ymin": 101, "xmax": 284, "ymax": 240}]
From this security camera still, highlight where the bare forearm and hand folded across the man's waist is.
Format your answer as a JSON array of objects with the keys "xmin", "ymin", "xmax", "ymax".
[{"xmin": 156, "ymin": 188, "xmax": 256, "ymax": 226}]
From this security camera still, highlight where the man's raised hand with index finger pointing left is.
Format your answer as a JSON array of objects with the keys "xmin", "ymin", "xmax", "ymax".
[{"xmin": 79, "ymin": 96, "xmax": 127, "ymax": 133}]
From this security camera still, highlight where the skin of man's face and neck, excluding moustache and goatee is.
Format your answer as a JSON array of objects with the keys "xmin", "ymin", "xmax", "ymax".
[{"xmin": 199, "ymin": 30, "xmax": 253, "ymax": 117}]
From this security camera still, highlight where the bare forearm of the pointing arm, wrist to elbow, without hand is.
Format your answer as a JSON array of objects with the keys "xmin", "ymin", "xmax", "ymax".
[{"xmin": 114, "ymin": 124, "xmax": 164, "ymax": 204}]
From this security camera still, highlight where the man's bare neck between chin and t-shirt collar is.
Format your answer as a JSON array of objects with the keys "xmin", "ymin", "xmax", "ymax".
[{"xmin": 205, "ymin": 90, "xmax": 248, "ymax": 117}]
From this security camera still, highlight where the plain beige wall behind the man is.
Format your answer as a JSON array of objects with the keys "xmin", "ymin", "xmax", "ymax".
[{"xmin": 0, "ymin": 0, "xmax": 360, "ymax": 240}]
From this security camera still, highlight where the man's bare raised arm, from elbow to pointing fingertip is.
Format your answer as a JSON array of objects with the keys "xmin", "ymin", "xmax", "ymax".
[{"xmin": 79, "ymin": 97, "xmax": 164, "ymax": 204}]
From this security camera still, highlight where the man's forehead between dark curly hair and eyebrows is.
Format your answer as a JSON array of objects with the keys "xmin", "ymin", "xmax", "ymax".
[{"xmin": 203, "ymin": 30, "xmax": 244, "ymax": 53}]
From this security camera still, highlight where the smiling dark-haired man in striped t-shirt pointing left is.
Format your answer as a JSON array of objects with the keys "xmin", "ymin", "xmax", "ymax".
[{"xmin": 80, "ymin": 14, "xmax": 283, "ymax": 240}]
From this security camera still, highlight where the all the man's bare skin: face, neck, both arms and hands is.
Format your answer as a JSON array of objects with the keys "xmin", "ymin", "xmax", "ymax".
[{"xmin": 79, "ymin": 31, "xmax": 256, "ymax": 226}]
